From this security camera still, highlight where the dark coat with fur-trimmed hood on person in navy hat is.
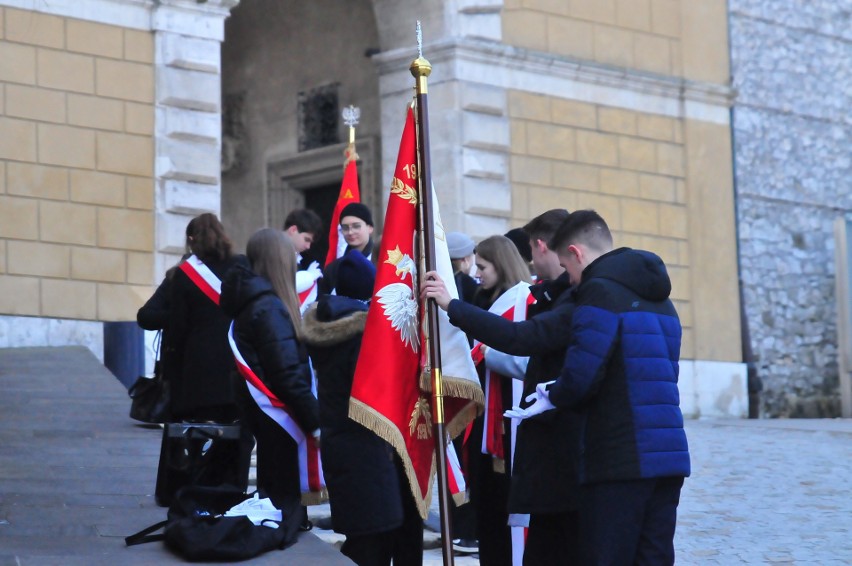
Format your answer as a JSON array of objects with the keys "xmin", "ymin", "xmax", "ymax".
[{"xmin": 304, "ymin": 295, "xmax": 410, "ymax": 535}]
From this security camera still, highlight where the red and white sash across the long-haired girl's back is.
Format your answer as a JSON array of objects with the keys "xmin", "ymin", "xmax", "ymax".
[{"xmin": 228, "ymin": 322, "xmax": 328, "ymax": 505}]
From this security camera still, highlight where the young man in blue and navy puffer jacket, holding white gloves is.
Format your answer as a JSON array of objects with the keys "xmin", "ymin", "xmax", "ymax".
[{"xmin": 536, "ymin": 210, "xmax": 690, "ymax": 565}]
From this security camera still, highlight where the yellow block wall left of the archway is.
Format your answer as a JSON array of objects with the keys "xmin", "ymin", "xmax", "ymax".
[{"xmin": 0, "ymin": 8, "xmax": 154, "ymax": 321}]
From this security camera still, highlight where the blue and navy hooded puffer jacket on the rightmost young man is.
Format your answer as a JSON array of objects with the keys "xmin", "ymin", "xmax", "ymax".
[{"xmin": 550, "ymin": 248, "xmax": 690, "ymax": 483}]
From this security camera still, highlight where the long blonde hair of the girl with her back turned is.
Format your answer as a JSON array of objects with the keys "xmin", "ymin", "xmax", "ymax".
[{"xmin": 246, "ymin": 228, "xmax": 302, "ymax": 338}]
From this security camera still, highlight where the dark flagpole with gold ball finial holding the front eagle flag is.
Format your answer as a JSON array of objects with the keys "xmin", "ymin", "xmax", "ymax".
[{"xmin": 409, "ymin": 21, "xmax": 453, "ymax": 566}]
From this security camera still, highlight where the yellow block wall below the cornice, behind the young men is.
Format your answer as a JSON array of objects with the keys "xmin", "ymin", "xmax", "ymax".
[{"xmin": 509, "ymin": 91, "xmax": 741, "ymax": 361}]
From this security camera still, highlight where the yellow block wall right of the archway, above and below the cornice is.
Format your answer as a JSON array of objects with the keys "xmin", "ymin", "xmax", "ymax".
[{"xmin": 502, "ymin": 0, "xmax": 742, "ymax": 362}]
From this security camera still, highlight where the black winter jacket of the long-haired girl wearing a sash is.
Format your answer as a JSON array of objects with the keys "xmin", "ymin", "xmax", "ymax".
[{"xmin": 221, "ymin": 265, "xmax": 319, "ymax": 434}]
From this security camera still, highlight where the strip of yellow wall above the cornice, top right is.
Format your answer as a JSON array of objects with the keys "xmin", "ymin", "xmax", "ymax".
[{"xmin": 503, "ymin": 0, "xmax": 729, "ymax": 83}]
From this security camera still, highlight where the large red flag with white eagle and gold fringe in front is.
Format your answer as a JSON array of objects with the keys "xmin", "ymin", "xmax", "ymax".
[{"xmin": 349, "ymin": 108, "xmax": 483, "ymax": 519}]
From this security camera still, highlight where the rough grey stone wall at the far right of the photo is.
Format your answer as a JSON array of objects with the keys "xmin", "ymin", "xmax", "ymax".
[{"xmin": 729, "ymin": 0, "xmax": 852, "ymax": 417}]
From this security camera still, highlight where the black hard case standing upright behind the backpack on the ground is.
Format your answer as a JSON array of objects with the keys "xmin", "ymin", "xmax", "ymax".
[{"xmin": 154, "ymin": 422, "xmax": 250, "ymax": 507}]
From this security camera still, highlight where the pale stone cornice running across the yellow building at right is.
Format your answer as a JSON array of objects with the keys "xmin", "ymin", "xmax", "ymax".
[{"xmin": 373, "ymin": 38, "xmax": 735, "ymax": 124}]
